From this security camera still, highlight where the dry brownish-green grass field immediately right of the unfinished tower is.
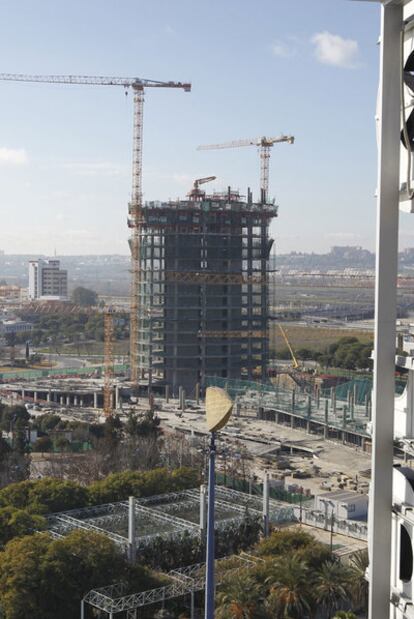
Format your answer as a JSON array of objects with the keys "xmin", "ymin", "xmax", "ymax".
[{"xmin": 270, "ymin": 323, "xmax": 374, "ymax": 351}]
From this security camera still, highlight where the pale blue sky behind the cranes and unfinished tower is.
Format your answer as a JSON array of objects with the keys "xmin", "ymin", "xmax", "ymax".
[{"xmin": 0, "ymin": 0, "xmax": 414, "ymax": 255}]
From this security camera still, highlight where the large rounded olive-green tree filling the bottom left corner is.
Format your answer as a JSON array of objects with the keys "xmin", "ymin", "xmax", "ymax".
[{"xmin": 0, "ymin": 531, "xmax": 127, "ymax": 619}]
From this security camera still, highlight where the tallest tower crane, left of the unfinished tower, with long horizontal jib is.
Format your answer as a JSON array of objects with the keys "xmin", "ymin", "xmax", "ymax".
[{"xmin": 0, "ymin": 73, "xmax": 191, "ymax": 386}]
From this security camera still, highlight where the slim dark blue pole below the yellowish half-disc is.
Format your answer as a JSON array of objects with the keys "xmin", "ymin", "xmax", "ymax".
[{"xmin": 204, "ymin": 432, "xmax": 216, "ymax": 619}]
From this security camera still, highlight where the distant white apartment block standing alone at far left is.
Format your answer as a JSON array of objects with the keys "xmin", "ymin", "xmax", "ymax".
[{"xmin": 29, "ymin": 258, "xmax": 68, "ymax": 301}]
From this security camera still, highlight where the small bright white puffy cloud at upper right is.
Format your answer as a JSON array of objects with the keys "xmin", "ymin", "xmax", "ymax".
[{"xmin": 311, "ymin": 31, "xmax": 359, "ymax": 69}]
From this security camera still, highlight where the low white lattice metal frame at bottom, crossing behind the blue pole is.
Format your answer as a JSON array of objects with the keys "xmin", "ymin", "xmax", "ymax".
[{"xmin": 81, "ymin": 555, "xmax": 255, "ymax": 619}]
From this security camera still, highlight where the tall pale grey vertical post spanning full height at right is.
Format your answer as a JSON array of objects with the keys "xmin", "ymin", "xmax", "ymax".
[{"xmin": 369, "ymin": 3, "xmax": 403, "ymax": 619}]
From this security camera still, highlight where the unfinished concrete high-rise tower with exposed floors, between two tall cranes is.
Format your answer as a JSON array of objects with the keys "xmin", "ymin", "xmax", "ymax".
[{"xmin": 138, "ymin": 188, "xmax": 277, "ymax": 394}]
